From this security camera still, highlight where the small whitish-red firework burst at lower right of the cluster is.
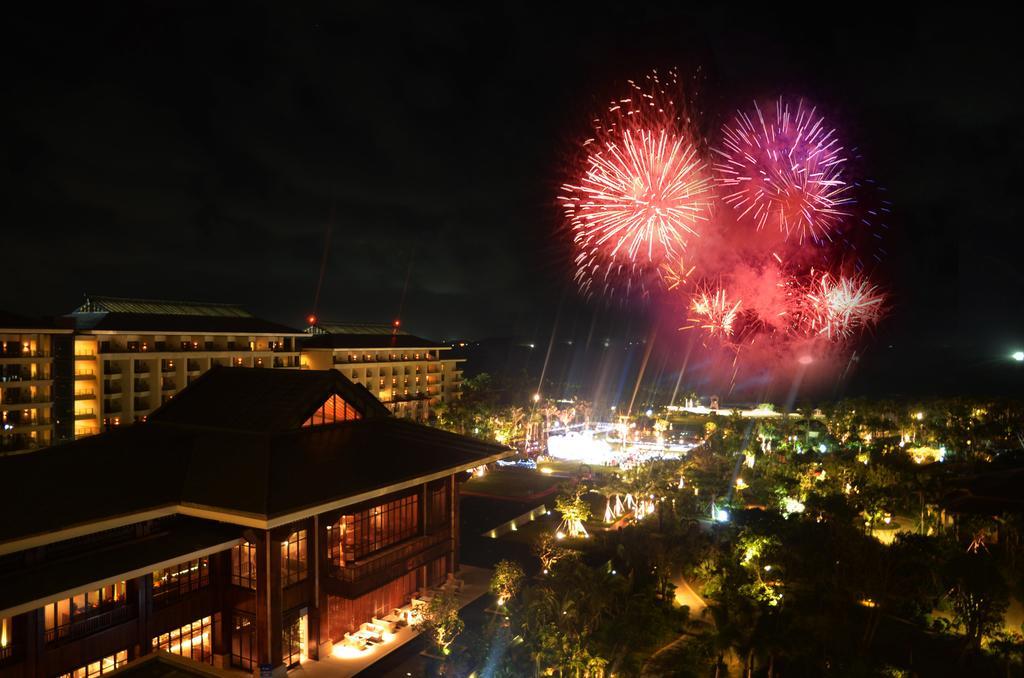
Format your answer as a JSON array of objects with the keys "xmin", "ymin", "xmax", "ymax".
[{"xmin": 803, "ymin": 272, "xmax": 886, "ymax": 341}]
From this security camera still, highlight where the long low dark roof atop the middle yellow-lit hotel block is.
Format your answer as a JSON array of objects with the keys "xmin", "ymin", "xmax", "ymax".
[{"xmin": 71, "ymin": 311, "xmax": 302, "ymax": 335}]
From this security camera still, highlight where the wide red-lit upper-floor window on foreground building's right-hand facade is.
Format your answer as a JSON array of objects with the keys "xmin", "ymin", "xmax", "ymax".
[{"xmin": 329, "ymin": 494, "xmax": 420, "ymax": 564}]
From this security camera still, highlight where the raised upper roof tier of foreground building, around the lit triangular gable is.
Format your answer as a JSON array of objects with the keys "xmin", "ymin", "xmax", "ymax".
[{"xmin": 150, "ymin": 367, "xmax": 390, "ymax": 433}]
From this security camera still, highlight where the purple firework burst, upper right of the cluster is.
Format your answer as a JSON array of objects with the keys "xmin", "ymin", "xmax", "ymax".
[{"xmin": 714, "ymin": 98, "xmax": 853, "ymax": 243}]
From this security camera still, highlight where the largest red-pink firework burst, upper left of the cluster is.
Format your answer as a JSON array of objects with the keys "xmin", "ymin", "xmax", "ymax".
[{"xmin": 559, "ymin": 75, "xmax": 713, "ymax": 301}]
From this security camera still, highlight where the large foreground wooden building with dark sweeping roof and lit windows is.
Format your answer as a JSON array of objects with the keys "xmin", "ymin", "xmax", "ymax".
[{"xmin": 0, "ymin": 368, "xmax": 511, "ymax": 678}]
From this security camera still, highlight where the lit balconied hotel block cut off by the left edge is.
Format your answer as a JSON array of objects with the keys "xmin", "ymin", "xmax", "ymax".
[{"xmin": 0, "ymin": 311, "xmax": 74, "ymax": 455}]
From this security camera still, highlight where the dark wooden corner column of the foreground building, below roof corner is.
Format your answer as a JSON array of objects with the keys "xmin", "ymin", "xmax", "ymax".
[{"xmin": 253, "ymin": 531, "xmax": 288, "ymax": 678}]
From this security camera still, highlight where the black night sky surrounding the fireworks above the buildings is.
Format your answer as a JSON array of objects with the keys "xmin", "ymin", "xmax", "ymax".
[{"xmin": 8, "ymin": 2, "xmax": 1024, "ymax": 390}]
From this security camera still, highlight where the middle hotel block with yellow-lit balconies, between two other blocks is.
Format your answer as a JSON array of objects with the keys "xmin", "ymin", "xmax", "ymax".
[{"xmin": 70, "ymin": 296, "xmax": 304, "ymax": 437}]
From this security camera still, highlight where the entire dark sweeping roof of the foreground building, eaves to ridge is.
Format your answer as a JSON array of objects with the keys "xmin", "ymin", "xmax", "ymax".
[{"xmin": 0, "ymin": 368, "xmax": 512, "ymax": 543}]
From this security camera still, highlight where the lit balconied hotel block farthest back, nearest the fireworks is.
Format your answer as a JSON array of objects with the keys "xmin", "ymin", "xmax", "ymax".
[{"xmin": 302, "ymin": 323, "xmax": 464, "ymax": 421}]
